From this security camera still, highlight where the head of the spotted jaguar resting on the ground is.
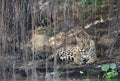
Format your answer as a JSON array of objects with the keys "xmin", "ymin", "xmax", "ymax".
[{"xmin": 76, "ymin": 36, "xmax": 95, "ymax": 63}]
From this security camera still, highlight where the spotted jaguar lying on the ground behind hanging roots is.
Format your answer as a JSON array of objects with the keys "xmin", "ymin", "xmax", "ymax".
[{"xmin": 49, "ymin": 35, "xmax": 97, "ymax": 64}]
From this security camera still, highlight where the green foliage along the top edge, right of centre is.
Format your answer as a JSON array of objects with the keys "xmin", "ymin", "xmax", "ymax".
[{"xmin": 58, "ymin": 0, "xmax": 106, "ymax": 18}]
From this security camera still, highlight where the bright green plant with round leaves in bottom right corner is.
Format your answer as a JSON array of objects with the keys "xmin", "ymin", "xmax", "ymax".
[{"xmin": 101, "ymin": 63, "xmax": 118, "ymax": 79}]
